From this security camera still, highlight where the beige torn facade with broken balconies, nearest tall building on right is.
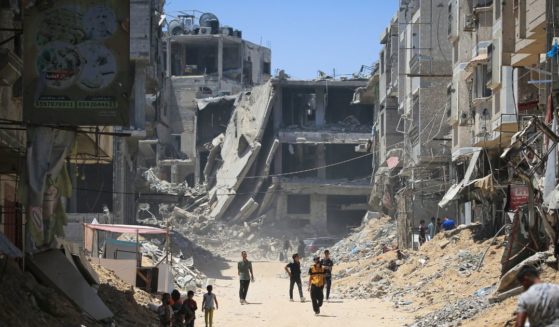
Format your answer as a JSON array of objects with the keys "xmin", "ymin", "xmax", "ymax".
[{"xmin": 441, "ymin": 0, "xmax": 548, "ymax": 233}]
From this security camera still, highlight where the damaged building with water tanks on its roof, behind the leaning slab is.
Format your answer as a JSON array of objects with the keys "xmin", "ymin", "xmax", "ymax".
[{"xmin": 160, "ymin": 13, "xmax": 271, "ymax": 186}]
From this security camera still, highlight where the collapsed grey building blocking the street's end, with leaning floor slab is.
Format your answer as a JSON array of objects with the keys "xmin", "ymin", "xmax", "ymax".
[{"xmin": 202, "ymin": 76, "xmax": 373, "ymax": 234}]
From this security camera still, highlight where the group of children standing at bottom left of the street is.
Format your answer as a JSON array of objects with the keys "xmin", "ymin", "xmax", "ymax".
[{"xmin": 157, "ymin": 285, "xmax": 219, "ymax": 327}]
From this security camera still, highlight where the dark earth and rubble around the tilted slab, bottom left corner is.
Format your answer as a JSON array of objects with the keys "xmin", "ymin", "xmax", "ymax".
[{"xmin": 0, "ymin": 259, "xmax": 159, "ymax": 327}]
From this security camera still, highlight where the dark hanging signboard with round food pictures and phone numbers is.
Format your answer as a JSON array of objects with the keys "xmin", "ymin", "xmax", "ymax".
[{"xmin": 23, "ymin": 0, "xmax": 131, "ymax": 125}]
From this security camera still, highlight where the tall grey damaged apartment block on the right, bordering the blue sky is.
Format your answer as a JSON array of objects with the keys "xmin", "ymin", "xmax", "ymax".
[{"xmin": 371, "ymin": 0, "xmax": 452, "ymax": 246}]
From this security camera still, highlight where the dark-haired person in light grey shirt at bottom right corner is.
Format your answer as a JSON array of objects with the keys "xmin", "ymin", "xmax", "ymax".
[{"xmin": 515, "ymin": 266, "xmax": 559, "ymax": 327}]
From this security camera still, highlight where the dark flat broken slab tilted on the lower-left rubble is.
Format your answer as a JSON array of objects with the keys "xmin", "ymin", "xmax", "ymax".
[{"xmin": 29, "ymin": 250, "xmax": 113, "ymax": 321}]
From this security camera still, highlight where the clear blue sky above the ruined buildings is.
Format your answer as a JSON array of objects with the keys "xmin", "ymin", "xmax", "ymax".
[{"xmin": 165, "ymin": 0, "xmax": 398, "ymax": 79}]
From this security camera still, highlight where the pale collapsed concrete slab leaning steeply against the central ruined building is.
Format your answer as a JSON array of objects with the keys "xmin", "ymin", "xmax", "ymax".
[{"xmin": 209, "ymin": 83, "xmax": 275, "ymax": 219}]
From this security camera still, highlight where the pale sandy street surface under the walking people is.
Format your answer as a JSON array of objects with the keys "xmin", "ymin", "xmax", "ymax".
[{"xmin": 196, "ymin": 261, "xmax": 413, "ymax": 327}]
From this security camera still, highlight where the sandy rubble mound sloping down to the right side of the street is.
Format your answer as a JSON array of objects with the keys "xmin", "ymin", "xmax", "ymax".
[{"xmin": 331, "ymin": 217, "xmax": 504, "ymax": 327}]
